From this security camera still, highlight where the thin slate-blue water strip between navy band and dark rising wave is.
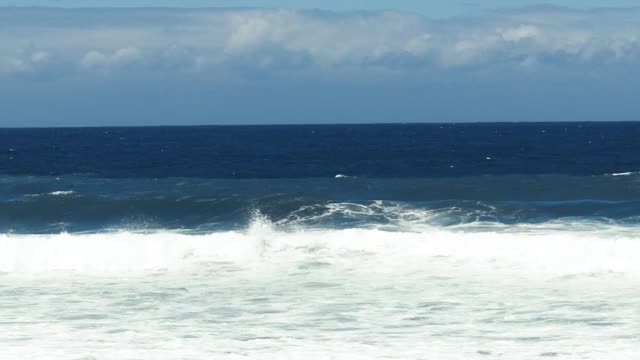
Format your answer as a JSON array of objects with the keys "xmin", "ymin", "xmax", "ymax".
[{"xmin": 5, "ymin": 172, "xmax": 640, "ymax": 201}]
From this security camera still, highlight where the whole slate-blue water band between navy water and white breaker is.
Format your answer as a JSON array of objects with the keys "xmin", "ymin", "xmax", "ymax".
[{"xmin": 0, "ymin": 175, "xmax": 640, "ymax": 233}]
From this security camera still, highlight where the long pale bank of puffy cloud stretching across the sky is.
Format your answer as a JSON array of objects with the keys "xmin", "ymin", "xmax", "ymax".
[{"xmin": 0, "ymin": 8, "xmax": 640, "ymax": 75}]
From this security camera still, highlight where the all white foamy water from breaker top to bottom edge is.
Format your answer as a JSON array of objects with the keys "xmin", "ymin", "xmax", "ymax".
[{"xmin": 0, "ymin": 215, "xmax": 640, "ymax": 359}]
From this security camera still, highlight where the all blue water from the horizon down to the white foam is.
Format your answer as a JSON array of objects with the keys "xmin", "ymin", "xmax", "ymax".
[{"xmin": 0, "ymin": 123, "xmax": 640, "ymax": 233}]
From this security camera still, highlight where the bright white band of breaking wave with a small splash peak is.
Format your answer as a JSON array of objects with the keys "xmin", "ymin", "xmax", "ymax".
[{"xmin": 0, "ymin": 218, "xmax": 640, "ymax": 277}]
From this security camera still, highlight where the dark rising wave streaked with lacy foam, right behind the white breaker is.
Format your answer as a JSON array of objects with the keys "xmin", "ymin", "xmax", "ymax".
[{"xmin": 0, "ymin": 195, "xmax": 640, "ymax": 234}]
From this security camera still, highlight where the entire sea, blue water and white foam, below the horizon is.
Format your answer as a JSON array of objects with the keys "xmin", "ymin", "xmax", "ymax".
[{"xmin": 0, "ymin": 122, "xmax": 640, "ymax": 360}]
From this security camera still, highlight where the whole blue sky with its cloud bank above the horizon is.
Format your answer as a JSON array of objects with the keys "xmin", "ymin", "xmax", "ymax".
[{"xmin": 0, "ymin": 0, "xmax": 640, "ymax": 127}]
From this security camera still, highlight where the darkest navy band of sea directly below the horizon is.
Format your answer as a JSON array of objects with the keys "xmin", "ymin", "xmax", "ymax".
[{"xmin": 0, "ymin": 123, "xmax": 640, "ymax": 179}]
